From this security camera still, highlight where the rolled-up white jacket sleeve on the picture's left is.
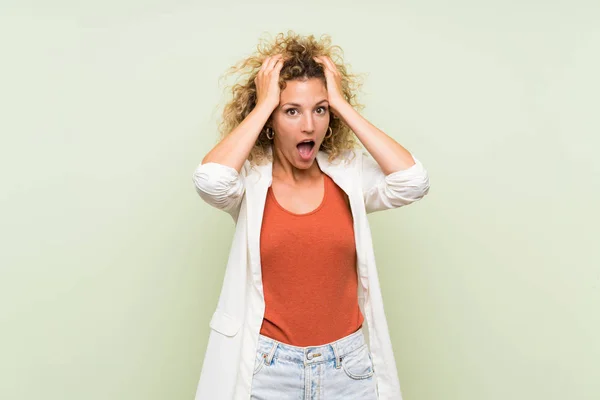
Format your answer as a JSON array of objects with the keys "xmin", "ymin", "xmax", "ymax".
[{"xmin": 193, "ymin": 162, "xmax": 245, "ymax": 221}]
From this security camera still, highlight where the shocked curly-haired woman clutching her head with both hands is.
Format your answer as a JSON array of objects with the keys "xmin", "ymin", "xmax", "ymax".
[{"xmin": 194, "ymin": 32, "xmax": 429, "ymax": 400}]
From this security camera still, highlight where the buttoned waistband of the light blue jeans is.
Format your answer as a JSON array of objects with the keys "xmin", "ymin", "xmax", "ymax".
[{"xmin": 258, "ymin": 329, "xmax": 366, "ymax": 366}]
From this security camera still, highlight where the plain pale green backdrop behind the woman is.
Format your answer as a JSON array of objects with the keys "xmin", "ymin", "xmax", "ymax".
[{"xmin": 0, "ymin": 0, "xmax": 600, "ymax": 400}]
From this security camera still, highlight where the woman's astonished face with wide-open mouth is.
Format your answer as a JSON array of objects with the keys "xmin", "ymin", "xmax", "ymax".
[{"xmin": 271, "ymin": 78, "xmax": 329, "ymax": 169}]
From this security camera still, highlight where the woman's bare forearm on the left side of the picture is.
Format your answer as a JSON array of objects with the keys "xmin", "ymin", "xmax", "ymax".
[{"xmin": 202, "ymin": 105, "xmax": 273, "ymax": 172}]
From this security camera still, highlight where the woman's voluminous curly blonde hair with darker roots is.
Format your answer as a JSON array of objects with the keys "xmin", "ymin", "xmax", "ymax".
[{"xmin": 219, "ymin": 31, "xmax": 364, "ymax": 165}]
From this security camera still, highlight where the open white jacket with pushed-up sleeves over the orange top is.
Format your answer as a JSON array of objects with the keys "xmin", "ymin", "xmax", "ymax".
[{"xmin": 193, "ymin": 149, "xmax": 429, "ymax": 400}]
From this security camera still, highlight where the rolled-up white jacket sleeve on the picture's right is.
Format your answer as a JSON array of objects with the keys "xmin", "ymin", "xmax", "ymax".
[{"xmin": 360, "ymin": 150, "xmax": 429, "ymax": 213}]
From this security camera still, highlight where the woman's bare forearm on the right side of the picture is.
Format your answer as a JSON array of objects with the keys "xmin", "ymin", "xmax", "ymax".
[{"xmin": 336, "ymin": 102, "xmax": 415, "ymax": 175}]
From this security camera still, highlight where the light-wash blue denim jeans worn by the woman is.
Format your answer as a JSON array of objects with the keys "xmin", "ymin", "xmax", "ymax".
[{"xmin": 251, "ymin": 329, "xmax": 378, "ymax": 400}]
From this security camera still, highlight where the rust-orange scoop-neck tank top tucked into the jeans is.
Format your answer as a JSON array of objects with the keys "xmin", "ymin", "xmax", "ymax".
[{"xmin": 260, "ymin": 174, "xmax": 364, "ymax": 347}]
